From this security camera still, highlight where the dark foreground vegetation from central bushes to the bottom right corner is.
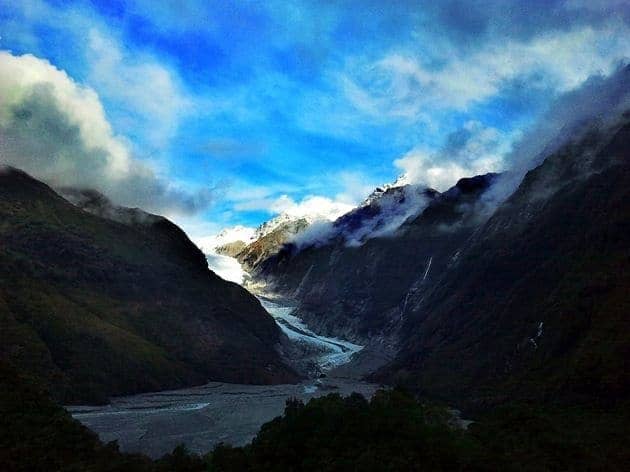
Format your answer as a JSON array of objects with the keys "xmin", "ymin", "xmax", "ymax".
[{"xmin": 208, "ymin": 390, "xmax": 630, "ymax": 472}]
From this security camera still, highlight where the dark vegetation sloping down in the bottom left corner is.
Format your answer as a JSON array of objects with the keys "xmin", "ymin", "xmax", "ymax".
[{"xmin": 0, "ymin": 362, "xmax": 205, "ymax": 472}]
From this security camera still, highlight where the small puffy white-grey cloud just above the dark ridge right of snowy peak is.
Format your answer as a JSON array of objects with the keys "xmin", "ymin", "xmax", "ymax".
[{"xmin": 394, "ymin": 121, "xmax": 511, "ymax": 191}]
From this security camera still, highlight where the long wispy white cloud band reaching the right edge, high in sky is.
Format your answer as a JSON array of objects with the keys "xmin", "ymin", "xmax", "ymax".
[{"xmin": 340, "ymin": 22, "xmax": 630, "ymax": 120}]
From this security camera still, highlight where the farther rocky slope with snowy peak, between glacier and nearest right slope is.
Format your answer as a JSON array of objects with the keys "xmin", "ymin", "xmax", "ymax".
[{"xmin": 254, "ymin": 174, "xmax": 495, "ymax": 347}]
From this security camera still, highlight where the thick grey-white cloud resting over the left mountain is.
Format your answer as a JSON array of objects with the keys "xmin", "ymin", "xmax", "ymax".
[{"xmin": 0, "ymin": 51, "xmax": 212, "ymax": 214}]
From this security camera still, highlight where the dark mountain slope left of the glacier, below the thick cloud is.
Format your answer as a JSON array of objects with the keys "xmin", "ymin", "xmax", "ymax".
[{"xmin": 0, "ymin": 168, "xmax": 297, "ymax": 403}]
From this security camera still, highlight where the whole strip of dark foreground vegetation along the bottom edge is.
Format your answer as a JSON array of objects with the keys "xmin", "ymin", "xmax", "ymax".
[{"xmin": 0, "ymin": 362, "xmax": 630, "ymax": 472}]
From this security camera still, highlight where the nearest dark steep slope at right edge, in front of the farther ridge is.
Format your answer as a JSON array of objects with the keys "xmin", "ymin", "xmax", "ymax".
[{"xmin": 378, "ymin": 119, "xmax": 630, "ymax": 406}]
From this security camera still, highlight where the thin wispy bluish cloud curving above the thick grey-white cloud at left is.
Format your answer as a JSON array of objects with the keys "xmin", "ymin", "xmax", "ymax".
[{"xmin": 0, "ymin": 0, "xmax": 197, "ymax": 155}]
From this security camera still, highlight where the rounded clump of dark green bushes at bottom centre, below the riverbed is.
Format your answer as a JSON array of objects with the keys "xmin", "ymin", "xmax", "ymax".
[{"xmin": 211, "ymin": 390, "xmax": 482, "ymax": 471}]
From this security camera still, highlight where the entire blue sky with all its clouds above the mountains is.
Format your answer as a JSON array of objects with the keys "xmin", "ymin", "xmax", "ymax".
[{"xmin": 0, "ymin": 0, "xmax": 630, "ymax": 240}]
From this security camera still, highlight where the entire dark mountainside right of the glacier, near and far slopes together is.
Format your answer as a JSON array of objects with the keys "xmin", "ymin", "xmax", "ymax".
[{"xmin": 246, "ymin": 113, "xmax": 630, "ymax": 408}]
